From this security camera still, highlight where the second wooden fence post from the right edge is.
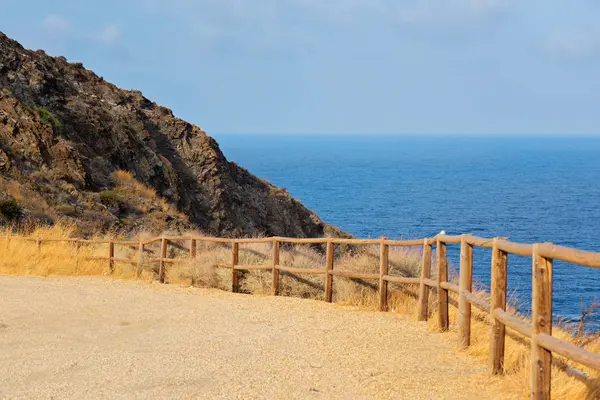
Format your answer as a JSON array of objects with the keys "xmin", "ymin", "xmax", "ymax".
[{"xmin": 490, "ymin": 238, "xmax": 508, "ymax": 375}]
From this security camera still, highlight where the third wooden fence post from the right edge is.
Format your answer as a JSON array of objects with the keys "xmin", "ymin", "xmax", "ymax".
[{"xmin": 458, "ymin": 235, "xmax": 473, "ymax": 349}]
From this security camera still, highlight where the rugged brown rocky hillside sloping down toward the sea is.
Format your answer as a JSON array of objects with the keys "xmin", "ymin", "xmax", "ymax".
[{"xmin": 0, "ymin": 32, "xmax": 345, "ymax": 237}]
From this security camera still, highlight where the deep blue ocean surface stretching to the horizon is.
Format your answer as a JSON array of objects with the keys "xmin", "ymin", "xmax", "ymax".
[{"xmin": 215, "ymin": 134, "xmax": 600, "ymax": 320}]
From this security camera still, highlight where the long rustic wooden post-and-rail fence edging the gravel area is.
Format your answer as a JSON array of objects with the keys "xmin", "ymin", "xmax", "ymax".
[{"xmin": 6, "ymin": 234, "xmax": 600, "ymax": 399}]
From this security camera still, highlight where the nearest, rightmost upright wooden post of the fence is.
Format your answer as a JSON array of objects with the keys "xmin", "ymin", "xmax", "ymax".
[{"xmin": 531, "ymin": 244, "xmax": 552, "ymax": 400}]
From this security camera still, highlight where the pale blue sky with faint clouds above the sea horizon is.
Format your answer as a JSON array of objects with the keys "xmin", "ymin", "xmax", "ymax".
[{"xmin": 0, "ymin": 0, "xmax": 600, "ymax": 135}]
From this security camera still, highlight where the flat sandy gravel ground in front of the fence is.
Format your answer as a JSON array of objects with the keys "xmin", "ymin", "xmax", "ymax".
[{"xmin": 0, "ymin": 276, "xmax": 491, "ymax": 399}]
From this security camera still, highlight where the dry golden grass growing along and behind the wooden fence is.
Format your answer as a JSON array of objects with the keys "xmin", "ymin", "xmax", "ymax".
[{"xmin": 0, "ymin": 226, "xmax": 600, "ymax": 399}]
